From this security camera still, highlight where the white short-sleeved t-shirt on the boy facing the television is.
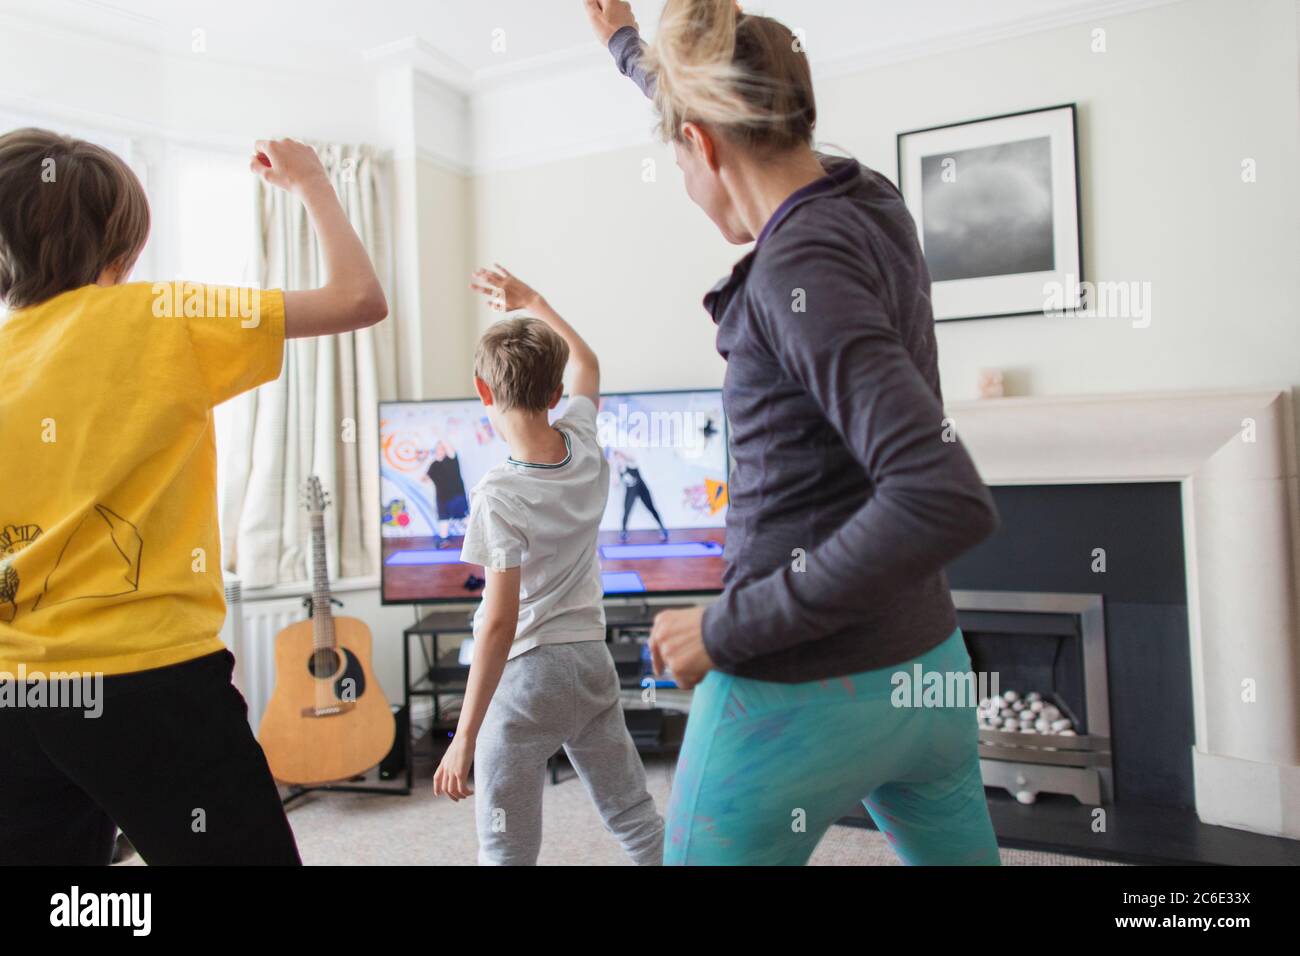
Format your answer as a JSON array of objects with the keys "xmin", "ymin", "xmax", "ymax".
[{"xmin": 460, "ymin": 395, "xmax": 610, "ymax": 658}]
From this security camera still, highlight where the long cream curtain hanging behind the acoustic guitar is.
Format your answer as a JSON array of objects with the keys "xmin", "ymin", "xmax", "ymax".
[{"xmin": 221, "ymin": 146, "xmax": 397, "ymax": 588}]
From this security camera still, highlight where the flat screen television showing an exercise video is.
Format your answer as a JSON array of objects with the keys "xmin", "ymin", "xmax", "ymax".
[{"xmin": 380, "ymin": 389, "xmax": 728, "ymax": 604}]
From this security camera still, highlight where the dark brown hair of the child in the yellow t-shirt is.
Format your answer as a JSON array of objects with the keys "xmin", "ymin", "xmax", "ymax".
[{"xmin": 0, "ymin": 129, "xmax": 150, "ymax": 308}]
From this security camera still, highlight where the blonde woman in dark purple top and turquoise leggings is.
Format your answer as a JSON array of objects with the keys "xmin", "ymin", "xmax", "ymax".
[{"xmin": 586, "ymin": 0, "xmax": 998, "ymax": 864}]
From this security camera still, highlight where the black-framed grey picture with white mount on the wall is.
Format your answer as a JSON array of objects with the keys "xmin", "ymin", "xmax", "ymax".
[{"xmin": 898, "ymin": 103, "xmax": 1083, "ymax": 321}]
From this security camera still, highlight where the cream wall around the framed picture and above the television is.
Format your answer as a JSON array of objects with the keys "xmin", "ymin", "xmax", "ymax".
[{"xmin": 475, "ymin": 0, "xmax": 1300, "ymax": 411}]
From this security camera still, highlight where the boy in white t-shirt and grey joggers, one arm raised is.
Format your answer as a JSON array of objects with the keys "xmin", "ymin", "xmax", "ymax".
[{"xmin": 433, "ymin": 265, "xmax": 663, "ymax": 865}]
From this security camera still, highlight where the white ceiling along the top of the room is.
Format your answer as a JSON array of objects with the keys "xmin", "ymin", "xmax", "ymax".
[{"xmin": 0, "ymin": 0, "xmax": 1167, "ymax": 81}]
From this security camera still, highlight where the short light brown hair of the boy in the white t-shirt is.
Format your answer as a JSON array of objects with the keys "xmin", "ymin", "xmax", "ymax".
[{"xmin": 475, "ymin": 319, "xmax": 568, "ymax": 411}]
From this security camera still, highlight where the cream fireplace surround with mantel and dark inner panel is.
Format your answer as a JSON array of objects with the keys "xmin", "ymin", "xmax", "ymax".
[{"xmin": 948, "ymin": 392, "xmax": 1300, "ymax": 838}]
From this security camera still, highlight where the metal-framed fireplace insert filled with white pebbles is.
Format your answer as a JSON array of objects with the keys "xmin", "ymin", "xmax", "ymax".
[{"xmin": 953, "ymin": 591, "xmax": 1114, "ymax": 805}]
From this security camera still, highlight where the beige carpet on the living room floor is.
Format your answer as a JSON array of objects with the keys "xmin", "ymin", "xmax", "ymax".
[{"xmin": 279, "ymin": 757, "xmax": 1109, "ymax": 866}]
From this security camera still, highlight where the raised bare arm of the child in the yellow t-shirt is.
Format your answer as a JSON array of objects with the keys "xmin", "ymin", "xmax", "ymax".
[{"xmin": 248, "ymin": 139, "xmax": 389, "ymax": 338}]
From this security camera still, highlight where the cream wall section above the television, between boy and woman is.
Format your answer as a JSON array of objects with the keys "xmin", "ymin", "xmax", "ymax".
[{"xmin": 475, "ymin": 146, "xmax": 745, "ymax": 389}]
